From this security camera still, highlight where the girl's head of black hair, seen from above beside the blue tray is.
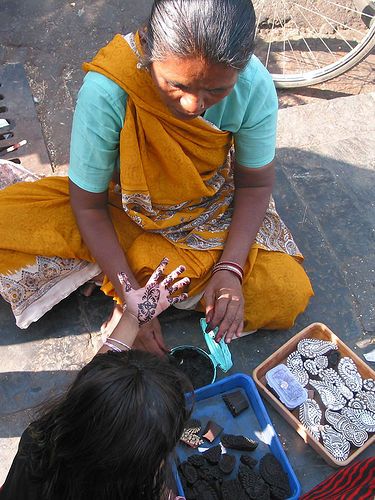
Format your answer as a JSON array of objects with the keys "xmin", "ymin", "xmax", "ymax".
[{"xmin": 31, "ymin": 351, "xmax": 188, "ymax": 500}]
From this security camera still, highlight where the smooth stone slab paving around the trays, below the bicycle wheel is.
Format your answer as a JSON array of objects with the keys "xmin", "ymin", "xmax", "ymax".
[{"xmin": 0, "ymin": 90, "xmax": 375, "ymax": 491}]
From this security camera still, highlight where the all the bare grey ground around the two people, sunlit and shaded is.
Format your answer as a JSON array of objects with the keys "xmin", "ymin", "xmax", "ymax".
[{"xmin": 0, "ymin": 0, "xmax": 375, "ymax": 491}]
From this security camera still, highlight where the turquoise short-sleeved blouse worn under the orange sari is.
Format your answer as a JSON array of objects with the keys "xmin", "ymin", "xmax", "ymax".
[{"xmin": 69, "ymin": 56, "xmax": 278, "ymax": 193}]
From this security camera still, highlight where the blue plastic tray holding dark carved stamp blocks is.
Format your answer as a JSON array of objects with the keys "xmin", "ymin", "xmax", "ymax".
[{"xmin": 176, "ymin": 373, "xmax": 301, "ymax": 500}]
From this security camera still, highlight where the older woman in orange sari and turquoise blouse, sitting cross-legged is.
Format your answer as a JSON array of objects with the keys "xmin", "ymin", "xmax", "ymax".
[{"xmin": 0, "ymin": 0, "xmax": 313, "ymax": 354}]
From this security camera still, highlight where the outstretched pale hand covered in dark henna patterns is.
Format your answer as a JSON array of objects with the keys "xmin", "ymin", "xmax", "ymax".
[{"xmin": 118, "ymin": 257, "xmax": 190, "ymax": 327}]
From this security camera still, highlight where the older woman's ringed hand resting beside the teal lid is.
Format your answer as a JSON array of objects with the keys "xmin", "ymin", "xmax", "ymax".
[{"xmin": 204, "ymin": 271, "xmax": 244, "ymax": 344}]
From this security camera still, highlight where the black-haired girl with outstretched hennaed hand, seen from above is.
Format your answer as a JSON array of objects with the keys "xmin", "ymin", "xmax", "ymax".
[{"xmin": 0, "ymin": 261, "xmax": 191, "ymax": 500}]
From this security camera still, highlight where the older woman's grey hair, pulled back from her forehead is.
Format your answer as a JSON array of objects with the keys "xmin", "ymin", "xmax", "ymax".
[{"xmin": 141, "ymin": 0, "xmax": 255, "ymax": 70}]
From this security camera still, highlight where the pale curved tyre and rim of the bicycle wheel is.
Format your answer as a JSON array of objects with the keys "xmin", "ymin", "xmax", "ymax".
[{"xmin": 271, "ymin": 24, "xmax": 375, "ymax": 89}]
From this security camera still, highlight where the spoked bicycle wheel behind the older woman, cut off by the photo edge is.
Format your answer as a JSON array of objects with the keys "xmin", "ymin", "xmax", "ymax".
[{"xmin": 254, "ymin": 0, "xmax": 375, "ymax": 88}]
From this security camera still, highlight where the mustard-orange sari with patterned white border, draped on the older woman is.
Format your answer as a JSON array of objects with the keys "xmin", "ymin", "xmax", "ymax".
[{"xmin": 0, "ymin": 35, "xmax": 313, "ymax": 329}]
